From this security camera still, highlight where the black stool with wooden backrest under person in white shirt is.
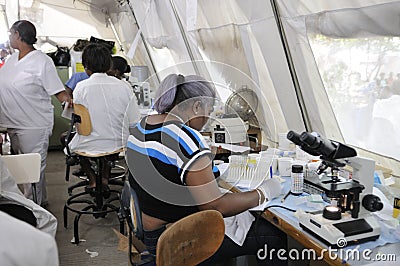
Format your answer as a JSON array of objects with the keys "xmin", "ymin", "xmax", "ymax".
[{"xmin": 63, "ymin": 107, "xmax": 124, "ymax": 244}]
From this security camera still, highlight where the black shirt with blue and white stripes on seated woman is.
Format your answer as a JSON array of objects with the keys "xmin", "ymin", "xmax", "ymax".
[{"xmin": 127, "ymin": 118, "xmax": 217, "ymax": 222}]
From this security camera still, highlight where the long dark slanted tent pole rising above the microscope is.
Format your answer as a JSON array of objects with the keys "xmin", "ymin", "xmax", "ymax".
[{"xmin": 270, "ymin": 0, "xmax": 312, "ymax": 131}]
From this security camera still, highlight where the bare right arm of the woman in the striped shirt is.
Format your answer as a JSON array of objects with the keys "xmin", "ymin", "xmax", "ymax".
[{"xmin": 186, "ymin": 156, "xmax": 264, "ymax": 216}]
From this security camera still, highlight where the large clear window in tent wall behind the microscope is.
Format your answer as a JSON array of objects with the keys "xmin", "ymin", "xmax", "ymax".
[{"xmin": 308, "ymin": 34, "xmax": 400, "ymax": 160}]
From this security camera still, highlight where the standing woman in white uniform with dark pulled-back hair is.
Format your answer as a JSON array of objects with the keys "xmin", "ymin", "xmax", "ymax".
[{"xmin": 0, "ymin": 20, "xmax": 70, "ymax": 206}]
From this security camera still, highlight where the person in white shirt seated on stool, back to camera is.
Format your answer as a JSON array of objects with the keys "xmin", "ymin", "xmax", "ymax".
[{"xmin": 69, "ymin": 44, "xmax": 140, "ymax": 195}]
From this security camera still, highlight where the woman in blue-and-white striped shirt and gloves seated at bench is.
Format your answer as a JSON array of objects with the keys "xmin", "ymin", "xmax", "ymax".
[{"xmin": 127, "ymin": 74, "xmax": 287, "ymax": 265}]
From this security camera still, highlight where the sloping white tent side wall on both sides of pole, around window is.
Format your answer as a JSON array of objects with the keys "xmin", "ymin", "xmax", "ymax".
[{"xmin": 126, "ymin": 0, "xmax": 400, "ymax": 177}]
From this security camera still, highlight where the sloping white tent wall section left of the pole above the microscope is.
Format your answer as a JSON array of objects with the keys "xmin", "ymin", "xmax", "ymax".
[{"xmin": 132, "ymin": 1, "xmax": 304, "ymax": 141}]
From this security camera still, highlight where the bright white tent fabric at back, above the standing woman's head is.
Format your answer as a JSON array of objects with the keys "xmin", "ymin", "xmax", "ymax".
[{"xmin": 6, "ymin": 0, "xmax": 114, "ymax": 47}]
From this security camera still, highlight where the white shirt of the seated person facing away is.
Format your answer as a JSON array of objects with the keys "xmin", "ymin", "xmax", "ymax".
[{"xmin": 70, "ymin": 73, "xmax": 140, "ymax": 154}]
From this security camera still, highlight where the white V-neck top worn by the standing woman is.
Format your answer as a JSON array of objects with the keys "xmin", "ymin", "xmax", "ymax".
[{"xmin": 0, "ymin": 50, "xmax": 64, "ymax": 129}]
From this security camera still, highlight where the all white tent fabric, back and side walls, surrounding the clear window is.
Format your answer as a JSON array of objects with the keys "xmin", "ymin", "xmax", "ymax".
[{"xmin": 4, "ymin": 0, "xmax": 400, "ymax": 175}]
